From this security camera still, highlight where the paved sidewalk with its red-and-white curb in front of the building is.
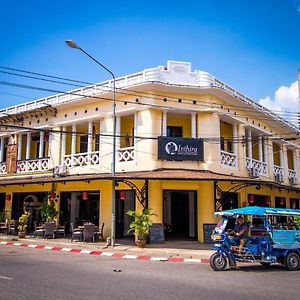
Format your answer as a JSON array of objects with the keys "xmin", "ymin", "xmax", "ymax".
[{"xmin": 0, "ymin": 235, "xmax": 213, "ymax": 263}]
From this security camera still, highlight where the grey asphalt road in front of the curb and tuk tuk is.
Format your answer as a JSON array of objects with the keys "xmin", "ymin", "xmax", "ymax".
[{"xmin": 0, "ymin": 246, "xmax": 300, "ymax": 300}]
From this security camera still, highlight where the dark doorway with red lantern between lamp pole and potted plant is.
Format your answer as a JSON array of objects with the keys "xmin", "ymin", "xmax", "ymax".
[{"xmin": 116, "ymin": 190, "xmax": 135, "ymax": 239}]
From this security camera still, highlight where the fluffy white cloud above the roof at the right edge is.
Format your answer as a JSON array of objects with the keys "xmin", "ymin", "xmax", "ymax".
[{"xmin": 258, "ymin": 81, "xmax": 299, "ymax": 113}]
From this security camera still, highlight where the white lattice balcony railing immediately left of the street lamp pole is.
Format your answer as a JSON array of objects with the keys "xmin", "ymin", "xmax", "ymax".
[{"xmin": 63, "ymin": 151, "xmax": 100, "ymax": 168}]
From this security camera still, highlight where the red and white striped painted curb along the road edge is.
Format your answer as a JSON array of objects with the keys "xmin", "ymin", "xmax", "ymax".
[{"xmin": 0, "ymin": 242, "xmax": 209, "ymax": 263}]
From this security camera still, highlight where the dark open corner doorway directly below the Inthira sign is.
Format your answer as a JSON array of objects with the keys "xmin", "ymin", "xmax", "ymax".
[{"xmin": 164, "ymin": 191, "xmax": 197, "ymax": 240}]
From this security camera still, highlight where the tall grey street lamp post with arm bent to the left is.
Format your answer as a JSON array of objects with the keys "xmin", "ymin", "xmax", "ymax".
[{"xmin": 66, "ymin": 40, "xmax": 116, "ymax": 247}]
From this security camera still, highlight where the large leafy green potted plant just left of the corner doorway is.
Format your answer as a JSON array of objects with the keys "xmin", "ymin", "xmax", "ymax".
[{"xmin": 127, "ymin": 208, "xmax": 154, "ymax": 248}]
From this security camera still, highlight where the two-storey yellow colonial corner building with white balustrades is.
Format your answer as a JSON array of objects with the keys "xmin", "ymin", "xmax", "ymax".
[{"xmin": 0, "ymin": 61, "xmax": 300, "ymax": 242}]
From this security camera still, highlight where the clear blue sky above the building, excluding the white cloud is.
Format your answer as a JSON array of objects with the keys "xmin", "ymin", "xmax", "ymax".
[{"xmin": 0, "ymin": 0, "xmax": 300, "ymax": 115}]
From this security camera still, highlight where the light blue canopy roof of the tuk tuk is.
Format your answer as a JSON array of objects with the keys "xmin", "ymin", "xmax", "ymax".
[{"xmin": 214, "ymin": 206, "xmax": 300, "ymax": 217}]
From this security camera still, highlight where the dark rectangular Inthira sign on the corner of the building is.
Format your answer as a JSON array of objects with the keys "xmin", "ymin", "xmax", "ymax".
[{"xmin": 158, "ymin": 136, "xmax": 203, "ymax": 161}]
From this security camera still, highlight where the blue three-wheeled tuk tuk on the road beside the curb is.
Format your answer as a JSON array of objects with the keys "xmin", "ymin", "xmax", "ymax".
[{"xmin": 210, "ymin": 206, "xmax": 300, "ymax": 271}]
